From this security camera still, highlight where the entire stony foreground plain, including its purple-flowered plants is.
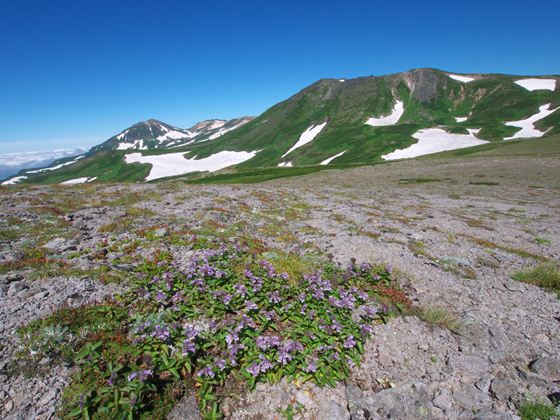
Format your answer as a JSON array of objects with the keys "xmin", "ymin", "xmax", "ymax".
[{"xmin": 0, "ymin": 140, "xmax": 560, "ymax": 420}]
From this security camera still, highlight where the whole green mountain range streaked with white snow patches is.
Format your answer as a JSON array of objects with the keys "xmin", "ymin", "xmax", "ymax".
[{"xmin": 3, "ymin": 69, "xmax": 560, "ymax": 183}]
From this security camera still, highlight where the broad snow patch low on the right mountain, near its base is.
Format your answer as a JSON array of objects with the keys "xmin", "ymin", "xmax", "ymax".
[{"xmin": 381, "ymin": 128, "xmax": 488, "ymax": 160}]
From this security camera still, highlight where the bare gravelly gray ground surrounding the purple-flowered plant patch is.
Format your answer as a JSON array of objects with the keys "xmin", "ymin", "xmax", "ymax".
[{"xmin": 0, "ymin": 157, "xmax": 560, "ymax": 419}]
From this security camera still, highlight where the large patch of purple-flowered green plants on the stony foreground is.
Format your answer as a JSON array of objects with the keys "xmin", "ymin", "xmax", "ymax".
[{"xmin": 15, "ymin": 235, "xmax": 404, "ymax": 418}]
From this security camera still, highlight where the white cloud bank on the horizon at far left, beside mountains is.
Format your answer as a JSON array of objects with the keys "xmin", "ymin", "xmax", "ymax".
[{"xmin": 0, "ymin": 148, "xmax": 87, "ymax": 179}]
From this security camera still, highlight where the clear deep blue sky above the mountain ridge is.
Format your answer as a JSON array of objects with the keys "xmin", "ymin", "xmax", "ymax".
[{"xmin": 0, "ymin": 0, "xmax": 560, "ymax": 153}]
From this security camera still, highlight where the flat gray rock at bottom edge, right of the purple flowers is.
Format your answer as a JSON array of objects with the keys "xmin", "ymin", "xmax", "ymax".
[{"xmin": 346, "ymin": 382, "xmax": 432, "ymax": 420}]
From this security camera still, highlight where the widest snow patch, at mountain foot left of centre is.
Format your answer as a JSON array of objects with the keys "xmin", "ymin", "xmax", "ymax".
[{"xmin": 124, "ymin": 150, "xmax": 258, "ymax": 181}]
